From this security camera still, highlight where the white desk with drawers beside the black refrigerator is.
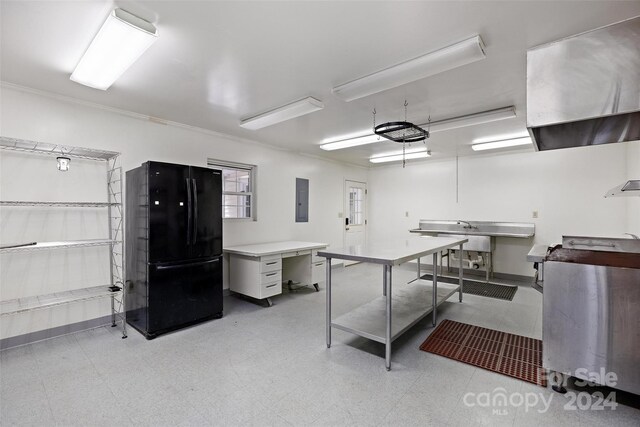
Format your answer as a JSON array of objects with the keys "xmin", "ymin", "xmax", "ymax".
[{"xmin": 223, "ymin": 241, "xmax": 327, "ymax": 306}]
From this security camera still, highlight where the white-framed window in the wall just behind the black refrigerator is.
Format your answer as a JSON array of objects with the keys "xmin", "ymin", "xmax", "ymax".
[{"xmin": 207, "ymin": 159, "xmax": 256, "ymax": 221}]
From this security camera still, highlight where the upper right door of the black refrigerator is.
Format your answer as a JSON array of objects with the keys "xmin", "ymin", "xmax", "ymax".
[{"xmin": 191, "ymin": 166, "xmax": 222, "ymax": 258}]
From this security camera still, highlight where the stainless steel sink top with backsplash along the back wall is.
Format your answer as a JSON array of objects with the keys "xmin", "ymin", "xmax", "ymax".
[{"xmin": 409, "ymin": 219, "xmax": 535, "ymax": 238}]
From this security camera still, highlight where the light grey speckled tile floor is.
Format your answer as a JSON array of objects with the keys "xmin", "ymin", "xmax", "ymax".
[{"xmin": 0, "ymin": 264, "xmax": 640, "ymax": 427}]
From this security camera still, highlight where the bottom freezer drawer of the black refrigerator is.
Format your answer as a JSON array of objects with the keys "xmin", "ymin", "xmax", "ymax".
[{"xmin": 147, "ymin": 257, "xmax": 222, "ymax": 338}]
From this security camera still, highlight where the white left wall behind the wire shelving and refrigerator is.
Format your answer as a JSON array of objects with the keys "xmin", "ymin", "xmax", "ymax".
[{"xmin": 0, "ymin": 87, "xmax": 367, "ymax": 338}]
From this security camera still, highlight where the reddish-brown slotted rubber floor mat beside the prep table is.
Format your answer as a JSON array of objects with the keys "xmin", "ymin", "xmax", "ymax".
[{"xmin": 420, "ymin": 319, "xmax": 547, "ymax": 387}]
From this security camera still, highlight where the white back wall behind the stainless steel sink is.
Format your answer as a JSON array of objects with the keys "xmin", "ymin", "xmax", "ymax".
[{"xmin": 369, "ymin": 142, "xmax": 640, "ymax": 276}]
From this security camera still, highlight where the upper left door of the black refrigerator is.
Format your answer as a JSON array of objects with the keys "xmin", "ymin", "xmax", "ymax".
[{"xmin": 148, "ymin": 162, "xmax": 191, "ymax": 263}]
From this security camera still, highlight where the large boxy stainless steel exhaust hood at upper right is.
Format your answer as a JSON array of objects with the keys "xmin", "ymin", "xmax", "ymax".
[{"xmin": 527, "ymin": 16, "xmax": 640, "ymax": 151}]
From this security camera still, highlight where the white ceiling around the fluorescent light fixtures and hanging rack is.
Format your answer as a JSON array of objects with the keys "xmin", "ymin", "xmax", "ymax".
[{"xmin": 0, "ymin": 0, "xmax": 640, "ymax": 166}]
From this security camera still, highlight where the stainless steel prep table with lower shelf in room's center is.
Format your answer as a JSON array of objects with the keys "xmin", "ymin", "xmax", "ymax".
[{"xmin": 318, "ymin": 237, "xmax": 467, "ymax": 370}]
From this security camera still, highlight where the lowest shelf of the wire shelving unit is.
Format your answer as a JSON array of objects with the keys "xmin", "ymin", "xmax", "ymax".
[{"xmin": 0, "ymin": 285, "xmax": 122, "ymax": 316}]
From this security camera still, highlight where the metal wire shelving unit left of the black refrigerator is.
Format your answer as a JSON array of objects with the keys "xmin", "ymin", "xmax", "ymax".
[{"xmin": 0, "ymin": 137, "xmax": 127, "ymax": 338}]
